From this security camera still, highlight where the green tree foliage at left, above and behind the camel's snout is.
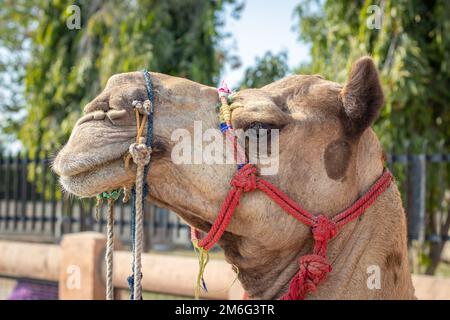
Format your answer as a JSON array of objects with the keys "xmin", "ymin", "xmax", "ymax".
[{"xmin": 1, "ymin": 0, "xmax": 242, "ymax": 153}]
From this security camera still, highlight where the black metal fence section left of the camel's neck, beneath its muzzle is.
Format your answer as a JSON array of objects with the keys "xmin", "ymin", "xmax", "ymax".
[{"xmin": 0, "ymin": 154, "xmax": 190, "ymax": 250}]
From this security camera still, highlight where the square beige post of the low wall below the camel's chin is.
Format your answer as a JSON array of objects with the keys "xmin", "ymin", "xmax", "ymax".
[{"xmin": 59, "ymin": 232, "xmax": 106, "ymax": 300}]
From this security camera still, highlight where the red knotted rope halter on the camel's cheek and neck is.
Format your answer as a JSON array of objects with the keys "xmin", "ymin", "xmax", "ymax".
[{"xmin": 191, "ymin": 82, "xmax": 393, "ymax": 300}]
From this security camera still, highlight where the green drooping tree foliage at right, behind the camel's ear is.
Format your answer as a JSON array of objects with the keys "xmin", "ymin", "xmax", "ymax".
[{"xmin": 296, "ymin": 0, "xmax": 450, "ymax": 273}]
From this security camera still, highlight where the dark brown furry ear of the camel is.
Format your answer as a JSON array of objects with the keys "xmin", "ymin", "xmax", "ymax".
[{"xmin": 341, "ymin": 57, "xmax": 384, "ymax": 136}]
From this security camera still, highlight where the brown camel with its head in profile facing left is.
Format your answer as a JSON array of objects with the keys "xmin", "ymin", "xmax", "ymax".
[{"xmin": 54, "ymin": 57, "xmax": 414, "ymax": 299}]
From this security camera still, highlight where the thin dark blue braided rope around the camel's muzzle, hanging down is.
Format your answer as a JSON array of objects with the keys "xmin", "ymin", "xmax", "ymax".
[{"xmin": 127, "ymin": 70, "xmax": 155, "ymax": 300}]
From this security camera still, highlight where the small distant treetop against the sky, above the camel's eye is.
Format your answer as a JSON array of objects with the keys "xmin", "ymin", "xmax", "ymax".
[{"xmin": 240, "ymin": 51, "xmax": 289, "ymax": 88}]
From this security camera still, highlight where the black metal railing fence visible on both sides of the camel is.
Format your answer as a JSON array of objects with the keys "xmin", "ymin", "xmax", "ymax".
[{"xmin": 0, "ymin": 154, "xmax": 450, "ymax": 248}]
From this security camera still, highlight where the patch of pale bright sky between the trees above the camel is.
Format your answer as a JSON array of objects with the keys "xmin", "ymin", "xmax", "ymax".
[{"xmin": 223, "ymin": 0, "xmax": 310, "ymax": 88}]
